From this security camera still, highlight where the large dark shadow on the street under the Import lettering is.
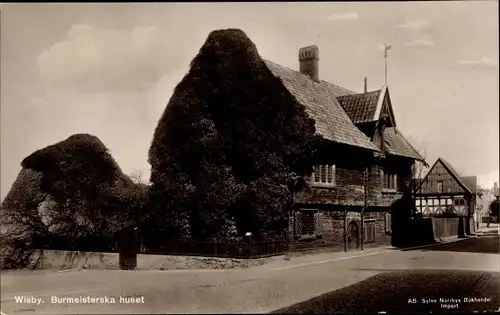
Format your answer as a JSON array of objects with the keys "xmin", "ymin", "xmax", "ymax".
[{"xmin": 271, "ymin": 270, "xmax": 500, "ymax": 314}]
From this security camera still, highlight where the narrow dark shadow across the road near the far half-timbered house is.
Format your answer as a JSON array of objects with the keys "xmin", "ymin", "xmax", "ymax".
[{"xmin": 408, "ymin": 234, "xmax": 500, "ymax": 254}]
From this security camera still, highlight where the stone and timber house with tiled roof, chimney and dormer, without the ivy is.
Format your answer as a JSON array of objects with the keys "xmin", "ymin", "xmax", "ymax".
[{"xmin": 265, "ymin": 45, "xmax": 425, "ymax": 250}]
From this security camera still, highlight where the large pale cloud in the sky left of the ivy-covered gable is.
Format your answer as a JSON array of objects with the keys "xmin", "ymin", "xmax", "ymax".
[{"xmin": 37, "ymin": 24, "xmax": 189, "ymax": 93}]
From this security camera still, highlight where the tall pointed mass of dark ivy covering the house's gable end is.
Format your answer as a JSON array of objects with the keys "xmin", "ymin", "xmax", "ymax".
[{"xmin": 149, "ymin": 29, "xmax": 317, "ymax": 239}]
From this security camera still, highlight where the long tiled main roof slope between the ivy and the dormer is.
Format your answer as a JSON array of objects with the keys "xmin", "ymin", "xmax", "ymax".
[{"xmin": 265, "ymin": 60, "xmax": 378, "ymax": 151}]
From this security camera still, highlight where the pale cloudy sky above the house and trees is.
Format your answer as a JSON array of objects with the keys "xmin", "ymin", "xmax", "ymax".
[{"xmin": 0, "ymin": 1, "xmax": 499, "ymax": 200}]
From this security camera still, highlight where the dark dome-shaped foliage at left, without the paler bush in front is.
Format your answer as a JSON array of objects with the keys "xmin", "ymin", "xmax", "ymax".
[{"xmin": 21, "ymin": 134, "xmax": 147, "ymax": 237}]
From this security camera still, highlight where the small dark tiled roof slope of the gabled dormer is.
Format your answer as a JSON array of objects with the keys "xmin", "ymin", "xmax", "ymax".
[{"xmin": 337, "ymin": 90, "xmax": 382, "ymax": 124}]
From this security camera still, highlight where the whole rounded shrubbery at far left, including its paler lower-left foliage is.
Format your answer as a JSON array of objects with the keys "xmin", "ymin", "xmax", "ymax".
[{"xmin": 1, "ymin": 134, "xmax": 149, "ymax": 268}]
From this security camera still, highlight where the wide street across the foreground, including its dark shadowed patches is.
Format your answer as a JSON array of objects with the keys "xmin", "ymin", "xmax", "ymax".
[{"xmin": 1, "ymin": 234, "xmax": 500, "ymax": 315}]
